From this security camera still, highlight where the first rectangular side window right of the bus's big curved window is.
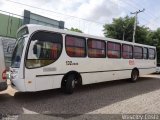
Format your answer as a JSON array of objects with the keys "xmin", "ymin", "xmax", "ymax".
[{"xmin": 66, "ymin": 35, "xmax": 86, "ymax": 57}]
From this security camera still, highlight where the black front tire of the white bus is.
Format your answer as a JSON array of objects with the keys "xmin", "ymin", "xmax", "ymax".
[{"xmin": 65, "ymin": 74, "xmax": 76, "ymax": 94}]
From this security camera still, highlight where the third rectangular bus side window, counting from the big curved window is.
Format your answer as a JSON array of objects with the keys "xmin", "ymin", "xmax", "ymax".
[{"xmin": 107, "ymin": 42, "xmax": 121, "ymax": 58}]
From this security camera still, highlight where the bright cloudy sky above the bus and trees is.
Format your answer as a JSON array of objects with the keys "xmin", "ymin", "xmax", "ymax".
[{"xmin": 0, "ymin": 0, "xmax": 160, "ymax": 36}]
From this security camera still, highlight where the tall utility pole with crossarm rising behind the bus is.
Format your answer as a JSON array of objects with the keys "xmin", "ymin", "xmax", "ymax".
[{"xmin": 131, "ymin": 9, "xmax": 145, "ymax": 43}]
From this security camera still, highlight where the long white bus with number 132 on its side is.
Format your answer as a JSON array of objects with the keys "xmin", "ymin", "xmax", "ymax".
[{"xmin": 10, "ymin": 25, "xmax": 156, "ymax": 93}]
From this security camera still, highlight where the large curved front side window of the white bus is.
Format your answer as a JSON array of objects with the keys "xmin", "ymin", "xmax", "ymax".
[{"xmin": 26, "ymin": 31, "xmax": 62, "ymax": 68}]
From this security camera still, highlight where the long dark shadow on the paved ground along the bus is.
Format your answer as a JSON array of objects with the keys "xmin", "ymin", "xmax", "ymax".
[{"xmin": 0, "ymin": 75, "xmax": 160, "ymax": 116}]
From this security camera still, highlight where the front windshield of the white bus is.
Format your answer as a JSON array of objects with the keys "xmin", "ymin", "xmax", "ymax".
[{"xmin": 11, "ymin": 37, "xmax": 25, "ymax": 68}]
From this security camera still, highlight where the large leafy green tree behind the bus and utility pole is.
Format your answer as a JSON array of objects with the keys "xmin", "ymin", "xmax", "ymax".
[{"xmin": 103, "ymin": 16, "xmax": 149, "ymax": 43}]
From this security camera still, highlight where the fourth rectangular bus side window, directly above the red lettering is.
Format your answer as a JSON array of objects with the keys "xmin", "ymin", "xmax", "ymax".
[{"xmin": 122, "ymin": 44, "xmax": 133, "ymax": 59}]
